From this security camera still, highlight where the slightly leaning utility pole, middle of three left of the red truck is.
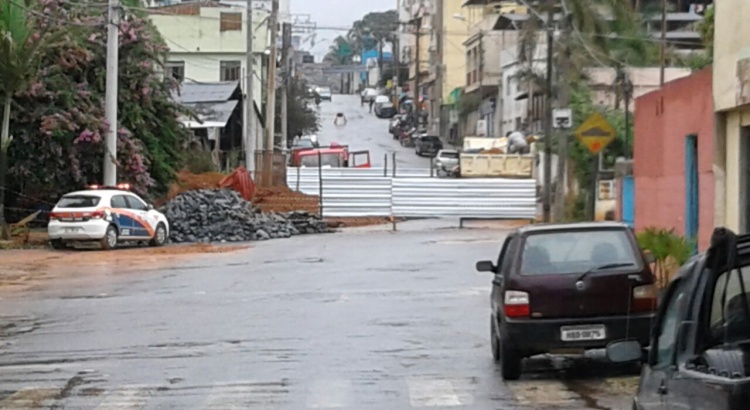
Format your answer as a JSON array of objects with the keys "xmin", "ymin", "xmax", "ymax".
[{"xmin": 263, "ymin": 0, "xmax": 279, "ymax": 186}]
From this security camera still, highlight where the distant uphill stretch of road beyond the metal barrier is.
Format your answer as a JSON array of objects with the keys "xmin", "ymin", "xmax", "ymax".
[{"xmin": 318, "ymin": 95, "xmax": 430, "ymax": 169}]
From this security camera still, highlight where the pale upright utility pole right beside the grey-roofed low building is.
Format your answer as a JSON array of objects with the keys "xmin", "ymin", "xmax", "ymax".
[{"xmin": 250, "ymin": 0, "xmax": 257, "ymax": 176}]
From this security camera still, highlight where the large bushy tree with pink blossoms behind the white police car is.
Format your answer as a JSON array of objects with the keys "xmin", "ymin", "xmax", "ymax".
[{"xmin": 0, "ymin": 0, "xmax": 192, "ymax": 213}]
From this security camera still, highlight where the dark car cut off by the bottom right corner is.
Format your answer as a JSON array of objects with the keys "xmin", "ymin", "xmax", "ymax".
[{"xmin": 607, "ymin": 228, "xmax": 750, "ymax": 410}]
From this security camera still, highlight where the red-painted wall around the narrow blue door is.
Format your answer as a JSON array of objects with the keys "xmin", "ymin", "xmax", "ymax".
[{"xmin": 633, "ymin": 67, "xmax": 714, "ymax": 250}]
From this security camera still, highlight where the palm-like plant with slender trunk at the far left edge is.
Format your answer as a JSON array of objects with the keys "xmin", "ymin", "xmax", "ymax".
[{"xmin": 0, "ymin": 0, "xmax": 50, "ymax": 231}]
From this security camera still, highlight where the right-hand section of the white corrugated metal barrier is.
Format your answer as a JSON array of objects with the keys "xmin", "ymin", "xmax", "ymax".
[{"xmin": 393, "ymin": 178, "xmax": 536, "ymax": 219}]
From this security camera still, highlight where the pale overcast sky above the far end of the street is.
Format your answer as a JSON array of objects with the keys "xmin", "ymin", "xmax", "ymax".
[{"xmin": 290, "ymin": 0, "xmax": 397, "ymax": 57}]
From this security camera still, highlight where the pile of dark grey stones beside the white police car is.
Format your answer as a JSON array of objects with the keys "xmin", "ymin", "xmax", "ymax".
[{"xmin": 160, "ymin": 189, "xmax": 330, "ymax": 243}]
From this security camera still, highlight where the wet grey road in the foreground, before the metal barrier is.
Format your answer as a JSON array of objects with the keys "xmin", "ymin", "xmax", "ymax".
[{"xmin": 0, "ymin": 221, "xmax": 640, "ymax": 410}]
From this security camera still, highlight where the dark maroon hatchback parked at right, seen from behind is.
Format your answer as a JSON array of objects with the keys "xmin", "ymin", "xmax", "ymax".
[{"xmin": 476, "ymin": 222, "xmax": 657, "ymax": 380}]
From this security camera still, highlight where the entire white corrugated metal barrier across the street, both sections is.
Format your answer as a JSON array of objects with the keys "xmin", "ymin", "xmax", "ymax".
[{"xmin": 286, "ymin": 168, "xmax": 536, "ymax": 223}]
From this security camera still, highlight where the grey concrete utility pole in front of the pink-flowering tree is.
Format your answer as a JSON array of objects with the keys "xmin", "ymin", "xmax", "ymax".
[{"xmin": 103, "ymin": 0, "xmax": 120, "ymax": 186}]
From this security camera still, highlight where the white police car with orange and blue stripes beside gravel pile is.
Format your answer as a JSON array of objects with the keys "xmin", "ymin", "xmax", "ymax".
[{"xmin": 47, "ymin": 184, "xmax": 169, "ymax": 250}]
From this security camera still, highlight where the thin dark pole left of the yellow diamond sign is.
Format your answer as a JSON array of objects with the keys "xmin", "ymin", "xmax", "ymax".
[{"xmin": 542, "ymin": 1, "xmax": 555, "ymax": 222}]
